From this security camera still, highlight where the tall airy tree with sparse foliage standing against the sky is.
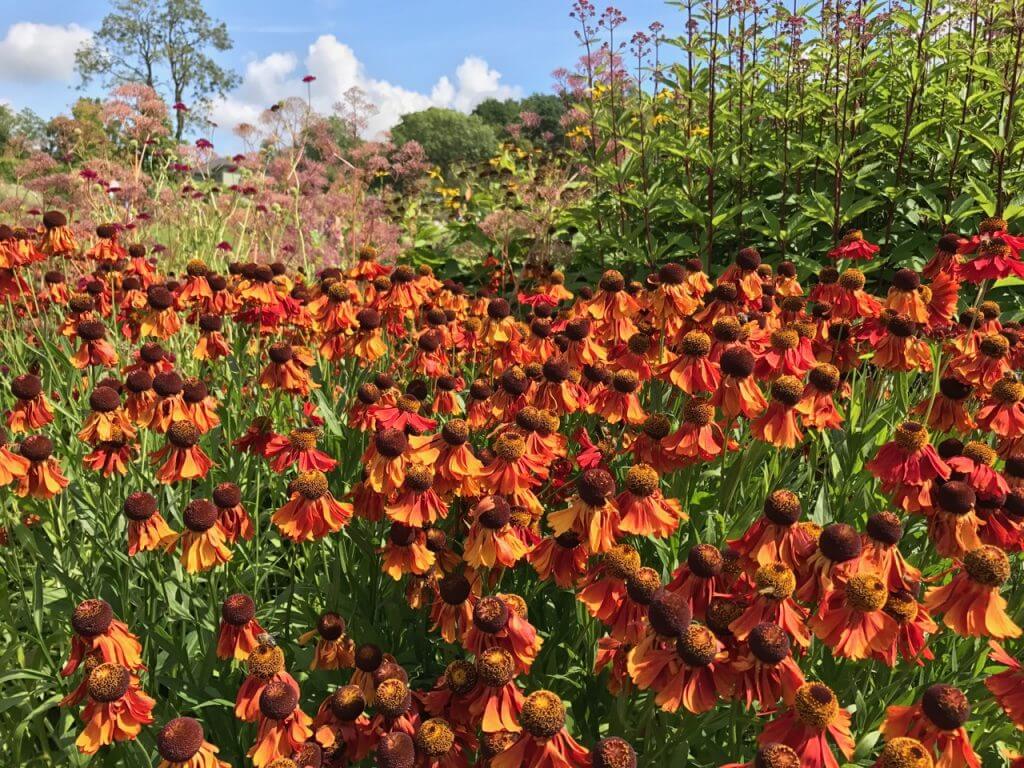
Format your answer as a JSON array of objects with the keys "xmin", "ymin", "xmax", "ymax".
[{"xmin": 75, "ymin": 0, "xmax": 239, "ymax": 140}]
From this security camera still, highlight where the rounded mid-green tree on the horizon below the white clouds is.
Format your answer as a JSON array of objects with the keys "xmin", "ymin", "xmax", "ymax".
[{"xmin": 391, "ymin": 106, "xmax": 498, "ymax": 174}]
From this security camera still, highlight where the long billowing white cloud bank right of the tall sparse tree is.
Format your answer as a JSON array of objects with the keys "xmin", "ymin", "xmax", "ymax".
[{"xmin": 212, "ymin": 35, "xmax": 520, "ymax": 136}]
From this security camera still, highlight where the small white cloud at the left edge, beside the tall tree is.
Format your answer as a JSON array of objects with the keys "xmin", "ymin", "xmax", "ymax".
[{"xmin": 0, "ymin": 22, "xmax": 92, "ymax": 83}]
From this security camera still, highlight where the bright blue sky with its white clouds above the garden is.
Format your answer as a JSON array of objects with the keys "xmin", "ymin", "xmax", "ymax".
[{"xmin": 0, "ymin": 0, "xmax": 682, "ymax": 145}]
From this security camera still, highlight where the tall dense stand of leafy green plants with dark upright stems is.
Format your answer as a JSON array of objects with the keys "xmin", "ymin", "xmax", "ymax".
[{"xmin": 566, "ymin": 0, "xmax": 1024, "ymax": 271}]
